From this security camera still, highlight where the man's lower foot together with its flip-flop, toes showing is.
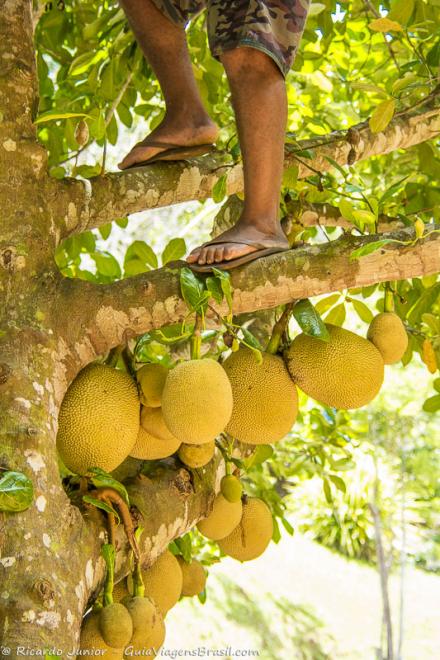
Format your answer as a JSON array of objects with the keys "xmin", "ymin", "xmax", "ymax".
[{"xmin": 187, "ymin": 218, "xmax": 289, "ymax": 270}]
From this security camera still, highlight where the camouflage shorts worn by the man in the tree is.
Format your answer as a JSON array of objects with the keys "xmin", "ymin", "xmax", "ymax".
[{"xmin": 153, "ymin": 0, "xmax": 310, "ymax": 75}]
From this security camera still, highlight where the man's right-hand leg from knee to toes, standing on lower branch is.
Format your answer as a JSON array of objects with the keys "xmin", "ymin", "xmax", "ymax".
[{"xmin": 188, "ymin": 47, "xmax": 288, "ymax": 264}]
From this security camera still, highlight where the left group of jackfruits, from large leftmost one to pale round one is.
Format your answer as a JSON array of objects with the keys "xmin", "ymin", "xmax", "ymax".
[{"xmin": 57, "ymin": 358, "xmax": 232, "ymax": 474}]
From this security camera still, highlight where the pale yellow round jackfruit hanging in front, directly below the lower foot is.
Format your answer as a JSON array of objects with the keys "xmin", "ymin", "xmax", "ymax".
[{"xmin": 162, "ymin": 358, "xmax": 232, "ymax": 445}]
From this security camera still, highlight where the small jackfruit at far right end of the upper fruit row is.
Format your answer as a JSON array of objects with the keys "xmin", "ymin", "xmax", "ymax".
[{"xmin": 367, "ymin": 312, "xmax": 408, "ymax": 364}]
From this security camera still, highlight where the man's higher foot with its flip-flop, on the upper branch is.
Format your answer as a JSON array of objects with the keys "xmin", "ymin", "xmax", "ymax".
[{"xmin": 118, "ymin": 115, "xmax": 218, "ymax": 170}]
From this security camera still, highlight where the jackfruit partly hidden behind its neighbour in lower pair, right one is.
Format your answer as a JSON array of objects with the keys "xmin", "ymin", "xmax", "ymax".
[{"xmin": 218, "ymin": 497, "xmax": 273, "ymax": 561}]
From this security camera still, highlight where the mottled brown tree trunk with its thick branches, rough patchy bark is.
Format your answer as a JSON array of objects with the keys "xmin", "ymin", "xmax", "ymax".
[{"xmin": 0, "ymin": 0, "xmax": 440, "ymax": 657}]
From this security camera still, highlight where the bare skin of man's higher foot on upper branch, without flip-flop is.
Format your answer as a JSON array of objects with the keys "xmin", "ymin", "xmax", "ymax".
[{"xmin": 118, "ymin": 115, "xmax": 218, "ymax": 170}]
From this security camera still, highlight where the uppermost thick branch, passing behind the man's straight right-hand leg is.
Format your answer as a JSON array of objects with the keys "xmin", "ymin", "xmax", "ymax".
[{"xmin": 57, "ymin": 90, "xmax": 440, "ymax": 238}]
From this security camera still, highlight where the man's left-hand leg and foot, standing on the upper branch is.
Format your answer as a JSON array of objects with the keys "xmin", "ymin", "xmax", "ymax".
[{"xmin": 119, "ymin": 0, "xmax": 218, "ymax": 169}]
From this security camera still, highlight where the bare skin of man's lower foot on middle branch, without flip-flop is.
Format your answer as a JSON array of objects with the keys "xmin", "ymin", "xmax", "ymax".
[{"xmin": 187, "ymin": 221, "xmax": 289, "ymax": 266}]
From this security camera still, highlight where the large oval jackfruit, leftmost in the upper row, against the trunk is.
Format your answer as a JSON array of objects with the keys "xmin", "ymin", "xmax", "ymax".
[{"xmin": 57, "ymin": 364, "xmax": 140, "ymax": 474}]
